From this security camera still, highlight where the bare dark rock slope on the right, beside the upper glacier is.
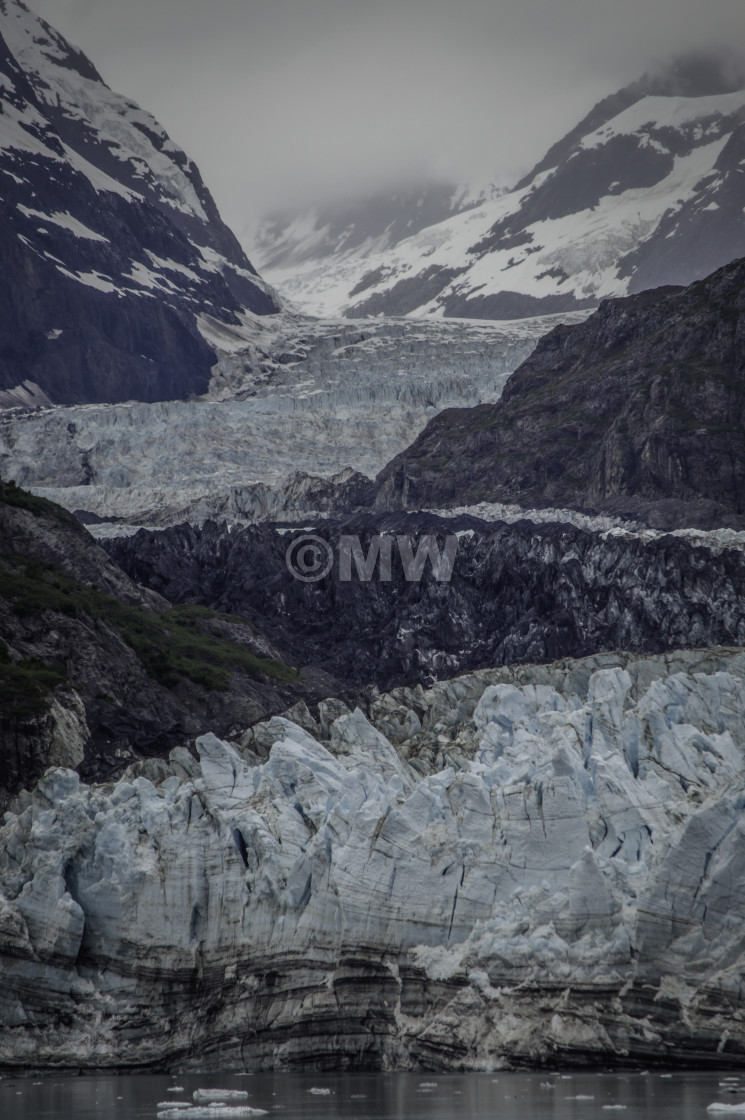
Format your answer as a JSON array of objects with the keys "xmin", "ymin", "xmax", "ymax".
[{"xmin": 375, "ymin": 260, "xmax": 745, "ymax": 529}]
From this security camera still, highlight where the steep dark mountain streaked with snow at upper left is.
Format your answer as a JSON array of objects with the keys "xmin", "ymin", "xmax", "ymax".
[{"xmin": 0, "ymin": 0, "xmax": 279, "ymax": 404}]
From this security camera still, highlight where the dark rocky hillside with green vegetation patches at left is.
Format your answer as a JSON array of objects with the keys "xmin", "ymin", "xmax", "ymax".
[{"xmin": 0, "ymin": 483, "xmax": 349, "ymax": 809}]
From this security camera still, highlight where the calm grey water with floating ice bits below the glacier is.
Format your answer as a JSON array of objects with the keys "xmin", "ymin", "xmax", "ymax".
[{"xmin": 0, "ymin": 1071, "xmax": 745, "ymax": 1120}]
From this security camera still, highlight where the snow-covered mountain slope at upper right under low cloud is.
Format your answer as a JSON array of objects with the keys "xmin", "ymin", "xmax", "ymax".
[{"xmin": 254, "ymin": 56, "xmax": 745, "ymax": 319}]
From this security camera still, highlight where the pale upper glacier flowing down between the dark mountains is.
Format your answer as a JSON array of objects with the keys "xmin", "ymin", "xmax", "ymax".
[{"xmin": 0, "ymin": 315, "xmax": 577, "ymax": 532}]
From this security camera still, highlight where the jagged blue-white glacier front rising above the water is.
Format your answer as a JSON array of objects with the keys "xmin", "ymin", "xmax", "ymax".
[{"xmin": 0, "ymin": 651, "xmax": 745, "ymax": 1070}]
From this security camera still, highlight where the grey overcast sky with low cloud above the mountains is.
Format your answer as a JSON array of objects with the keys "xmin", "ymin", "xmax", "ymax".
[{"xmin": 27, "ymin": 0, "xmax": 745, "ymax": 231}]
